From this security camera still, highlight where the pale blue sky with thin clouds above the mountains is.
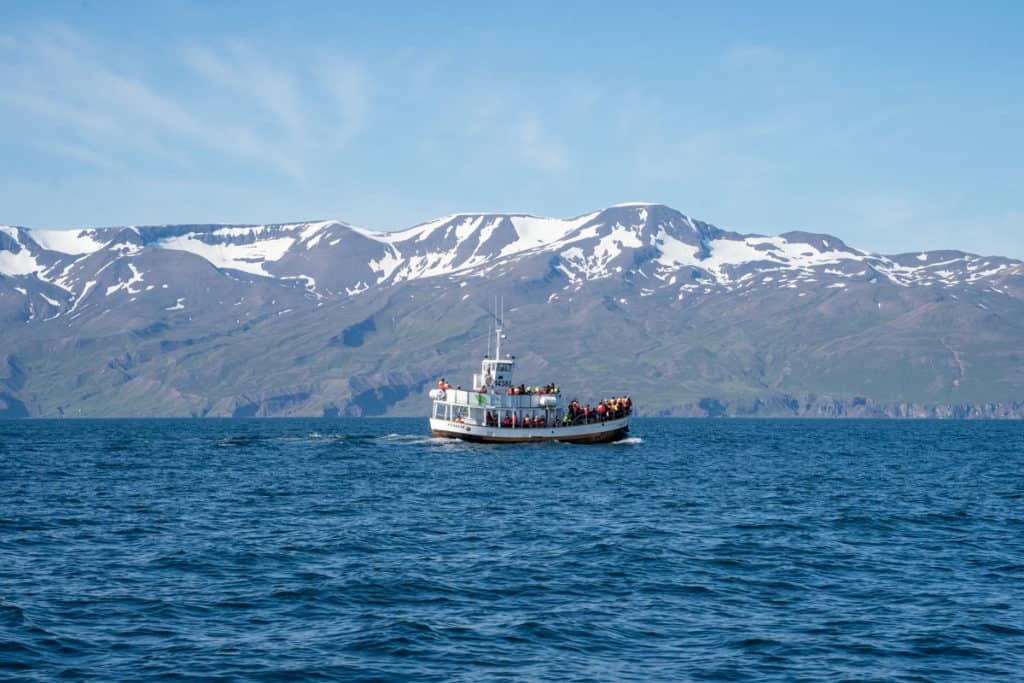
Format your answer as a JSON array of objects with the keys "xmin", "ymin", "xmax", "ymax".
[{"xmin": 0, "ymin": 1, "xmax": 1024, "ymax": 258}]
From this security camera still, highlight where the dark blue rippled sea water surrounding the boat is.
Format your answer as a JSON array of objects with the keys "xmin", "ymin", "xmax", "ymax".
[{"xmin": 0, "ymin": 420, "xmax": 1024, "ymax": 681}]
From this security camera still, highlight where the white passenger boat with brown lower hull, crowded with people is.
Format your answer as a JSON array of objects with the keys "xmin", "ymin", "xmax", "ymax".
[{"xmin": 430, "ymin": 325, "xmax": 633, "ymax": 443}]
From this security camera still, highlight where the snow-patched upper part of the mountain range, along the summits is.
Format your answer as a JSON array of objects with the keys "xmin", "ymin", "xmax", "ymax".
[{"xmin": 0, "ymin": 205, "xmax": 1021, "ymax": 308}]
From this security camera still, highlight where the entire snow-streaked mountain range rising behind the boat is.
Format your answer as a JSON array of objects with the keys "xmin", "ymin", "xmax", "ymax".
[{"xmin": 0, "ymin": 203, "xmax": 1024, "ymax": 417}]
